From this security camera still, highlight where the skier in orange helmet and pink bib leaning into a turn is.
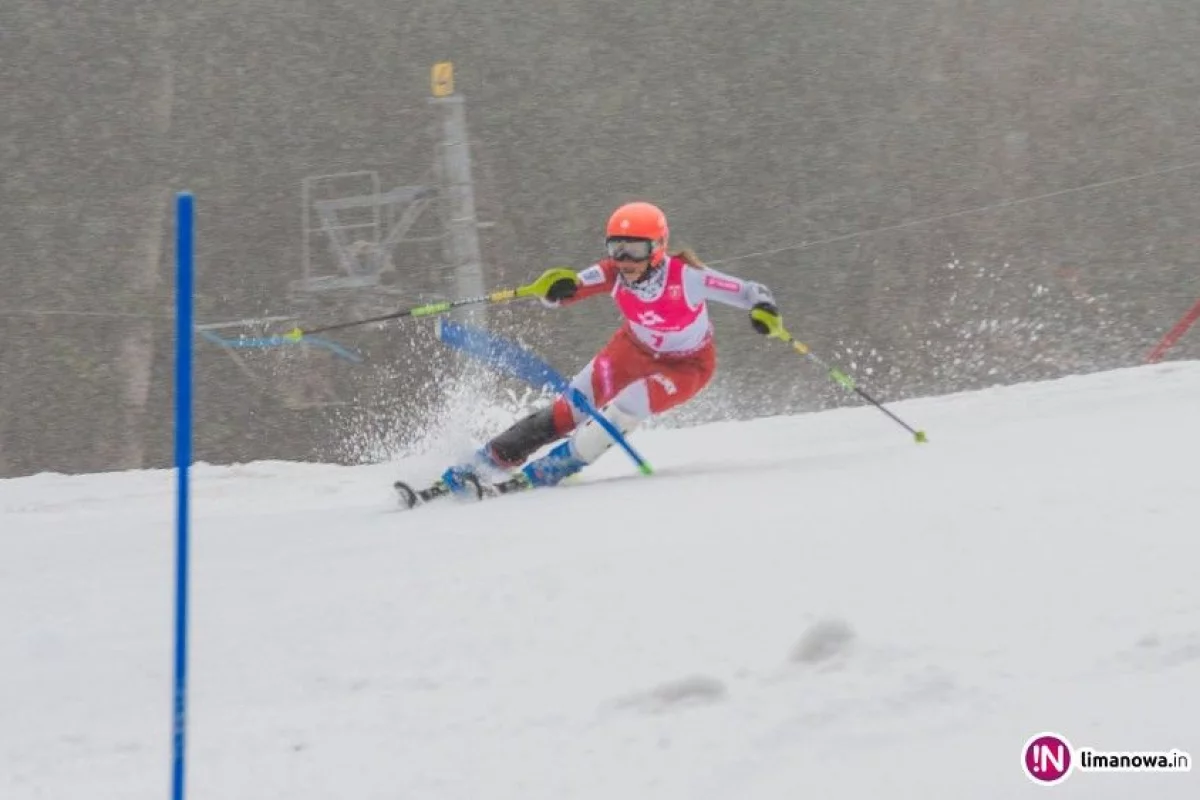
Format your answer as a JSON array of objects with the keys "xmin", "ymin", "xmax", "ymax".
[{"xmin": 442, "ymin": 201, "xmax": 779, "ymax": 493}]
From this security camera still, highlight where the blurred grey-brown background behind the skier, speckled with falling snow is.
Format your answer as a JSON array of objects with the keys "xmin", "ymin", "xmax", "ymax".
[{"xmin": 0, "ymin": 0, "xmax": 1200, "ymax": 475}]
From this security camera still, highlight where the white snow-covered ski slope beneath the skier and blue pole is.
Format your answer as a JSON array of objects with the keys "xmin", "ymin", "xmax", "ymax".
[{"xmin": 0, "ymin": 363, "xmax": 1200, "ymax": 800}]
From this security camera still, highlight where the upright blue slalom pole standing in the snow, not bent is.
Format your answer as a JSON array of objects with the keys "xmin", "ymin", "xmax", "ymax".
[{"xmin": 170, "ymin": 192, "xmax": 193, "ymax": 800}]
